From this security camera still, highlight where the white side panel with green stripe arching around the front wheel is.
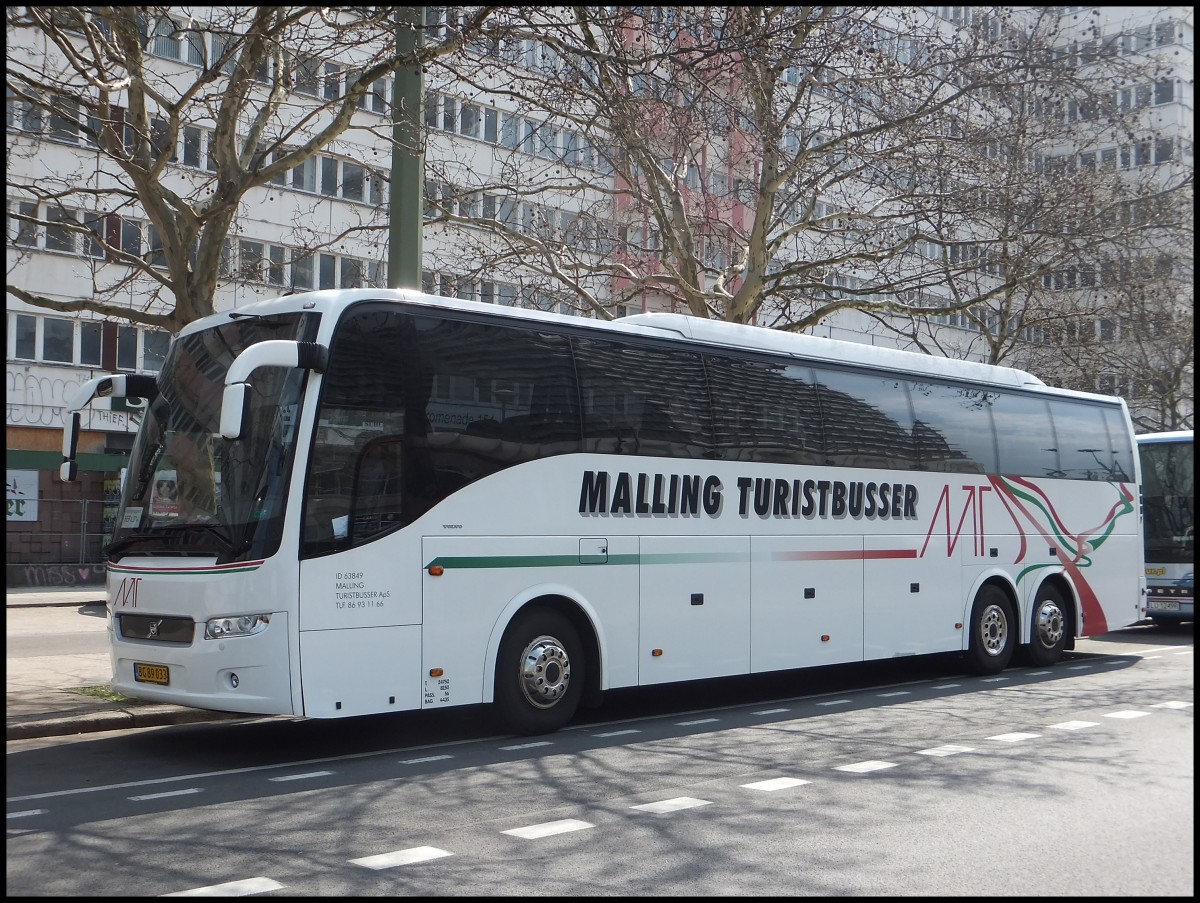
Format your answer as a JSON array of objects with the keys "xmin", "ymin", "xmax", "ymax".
[{"xmin": 421, "ymin": 533, "xmax": 638, "ymax": 708}]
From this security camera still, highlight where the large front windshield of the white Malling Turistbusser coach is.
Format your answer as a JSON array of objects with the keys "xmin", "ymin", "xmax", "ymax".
[{"xmin": 107, "ymin": 313, "xmax": 318, "ymax": 563}]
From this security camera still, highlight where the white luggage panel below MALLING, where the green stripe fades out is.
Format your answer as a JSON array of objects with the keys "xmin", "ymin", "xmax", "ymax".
[{"xmin": 640, "ymin": 536, "xmax": 750, "ymax": 686}]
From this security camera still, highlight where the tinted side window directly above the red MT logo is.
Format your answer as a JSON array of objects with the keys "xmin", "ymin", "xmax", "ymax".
[{"xmin": 911, "ymin": 382, "xmax": 996, "ymax": 473}]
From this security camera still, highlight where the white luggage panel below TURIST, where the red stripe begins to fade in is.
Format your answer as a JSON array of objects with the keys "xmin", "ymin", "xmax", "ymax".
[{"xmin": 750, "ymin": 536, "xmax": 863, "ymax": 672}]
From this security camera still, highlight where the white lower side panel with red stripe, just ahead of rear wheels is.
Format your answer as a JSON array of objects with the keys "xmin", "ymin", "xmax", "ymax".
[{"xmin": 863, "ymin": 534, "xmax": 970, "ymax": 659}]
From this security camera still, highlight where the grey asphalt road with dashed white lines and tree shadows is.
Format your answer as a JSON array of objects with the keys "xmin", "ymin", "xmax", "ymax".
[{"xmin": 6, "ymin": 627, "xmax": 1194, "ymax": 897}]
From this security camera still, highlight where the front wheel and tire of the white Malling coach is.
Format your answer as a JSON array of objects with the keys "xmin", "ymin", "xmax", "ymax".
[{"xmin": 494, "ymin": 609, "xmax": 586, "ymax": 736}]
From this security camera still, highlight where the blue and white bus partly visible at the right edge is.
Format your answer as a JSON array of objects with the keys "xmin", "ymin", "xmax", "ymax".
[{"xmin": 1138, "ymin": 430, "xmax": 1196, "ymax": 623}]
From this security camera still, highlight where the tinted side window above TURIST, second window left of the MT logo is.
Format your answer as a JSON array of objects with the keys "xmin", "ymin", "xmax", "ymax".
[{"xmin": 704, "ymin": 355, "xmax": 824, "ymax": 465}]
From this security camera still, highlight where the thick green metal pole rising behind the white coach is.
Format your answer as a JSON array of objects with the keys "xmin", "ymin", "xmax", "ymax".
[{"xmin": 388, "ymin": 6, "xmax": 425, "ymax": 289}]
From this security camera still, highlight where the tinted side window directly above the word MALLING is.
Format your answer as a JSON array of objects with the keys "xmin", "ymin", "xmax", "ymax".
[{"xmin": 575, "ymin": 337, "xmax": 712, "ymax": 458}]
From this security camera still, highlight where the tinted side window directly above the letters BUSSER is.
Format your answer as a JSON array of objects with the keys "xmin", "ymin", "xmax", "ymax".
[{"xmin": 816, "ymin": 370, "xmax": 917, "ymax": 470}]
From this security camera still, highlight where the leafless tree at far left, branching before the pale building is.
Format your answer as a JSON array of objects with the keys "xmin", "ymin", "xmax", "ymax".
[{"xmin": 6, "ymin": 6, "xmax": 491, "ymax": 331}]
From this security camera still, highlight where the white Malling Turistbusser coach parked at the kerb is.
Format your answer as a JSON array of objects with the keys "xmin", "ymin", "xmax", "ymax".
[{"xmin": 62, "ymin": 289, "xmax": 1145, "ymax": 734}]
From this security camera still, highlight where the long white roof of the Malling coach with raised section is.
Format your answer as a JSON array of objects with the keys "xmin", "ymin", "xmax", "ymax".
[{"xmin": 194, "ymin": 288, "xmax": 1114, "ymax": 401}]
